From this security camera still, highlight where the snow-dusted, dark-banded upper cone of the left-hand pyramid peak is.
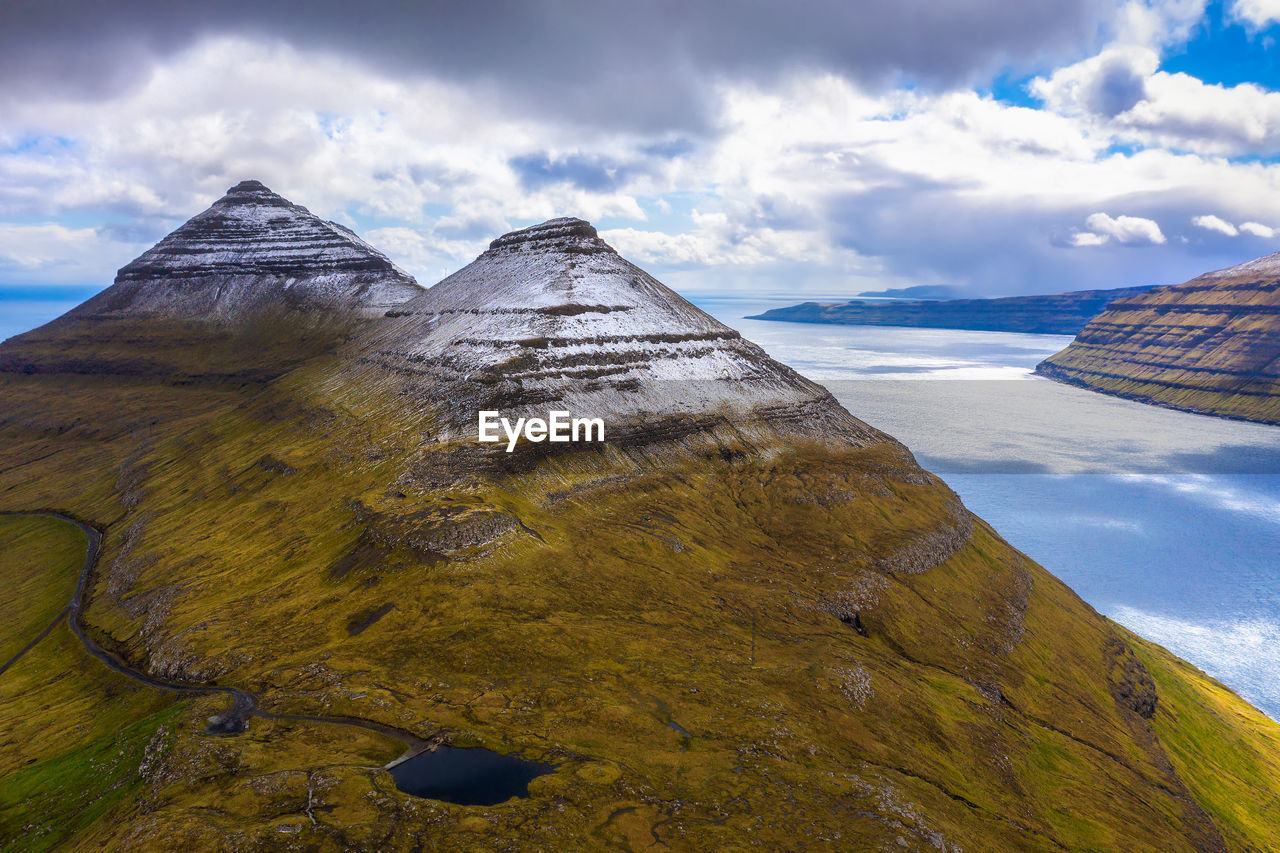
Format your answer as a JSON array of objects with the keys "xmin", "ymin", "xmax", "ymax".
[{"xmin": 69, "ymin": 181, "xmax": 422, "ymax": 323}]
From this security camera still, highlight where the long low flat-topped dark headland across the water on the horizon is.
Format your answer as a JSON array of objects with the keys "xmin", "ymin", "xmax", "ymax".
[{"xmin": 750, "ymin": 286, "xmax": 1155, "ymax": 334}]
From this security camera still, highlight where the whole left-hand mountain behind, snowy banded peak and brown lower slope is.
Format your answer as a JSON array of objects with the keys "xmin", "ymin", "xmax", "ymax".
[{"xmin": 0, "ymin": 181, "xmax": 422, "ymax": 560}]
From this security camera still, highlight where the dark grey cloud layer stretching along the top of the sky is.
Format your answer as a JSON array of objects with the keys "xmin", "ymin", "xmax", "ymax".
[{"xmin": 0, "ymin": 0, "xmax": 1114, "ymax": 128}]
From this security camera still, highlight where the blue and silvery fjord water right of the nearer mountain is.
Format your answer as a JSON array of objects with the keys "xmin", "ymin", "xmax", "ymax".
[{"xmin": 695, "ymin": 296, "xmax": 1280, "ymax": 719}]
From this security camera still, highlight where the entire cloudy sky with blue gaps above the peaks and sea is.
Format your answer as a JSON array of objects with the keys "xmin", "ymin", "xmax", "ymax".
[{"xmin": 0, "ymin": 0, "xmax": 1280, "ymax": 298}]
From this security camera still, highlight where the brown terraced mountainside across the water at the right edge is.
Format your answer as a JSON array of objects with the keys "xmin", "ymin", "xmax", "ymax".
[{"xmin": 1036, "ymin": 252, "xmax": 1280, "ymax": 424}]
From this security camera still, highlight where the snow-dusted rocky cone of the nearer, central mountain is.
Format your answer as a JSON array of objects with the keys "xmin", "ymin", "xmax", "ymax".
[{"xmin": 344, "ymin": 218, "xmax": 883, "ymax": 447}]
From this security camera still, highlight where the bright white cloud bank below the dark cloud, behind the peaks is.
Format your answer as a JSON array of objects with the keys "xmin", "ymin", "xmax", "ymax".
[{"xmin": 0, "ymin": 4, "xmax": 1280, "ymax": 295}]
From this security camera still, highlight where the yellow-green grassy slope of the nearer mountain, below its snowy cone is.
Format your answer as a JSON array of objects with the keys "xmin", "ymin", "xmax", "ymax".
[{"xmin": 0, "ymin": 318, "xmax": 1280, "ymax": 850}]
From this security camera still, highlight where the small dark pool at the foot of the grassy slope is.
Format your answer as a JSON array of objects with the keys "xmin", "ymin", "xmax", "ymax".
[{"xmin": 390, "ymin": 747, "xmax": 556, "ymax": 806}]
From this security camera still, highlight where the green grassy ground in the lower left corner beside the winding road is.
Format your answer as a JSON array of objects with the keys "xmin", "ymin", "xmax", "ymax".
[{"xmin": 0, "ymin": 507, "xmax": 181, "ymax": 850}]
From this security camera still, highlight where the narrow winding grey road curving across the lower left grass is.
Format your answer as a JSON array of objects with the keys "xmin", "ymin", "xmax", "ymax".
[{"xmin": 0, "ymin": 511, "xmax": 439, "ymax": 766}]
